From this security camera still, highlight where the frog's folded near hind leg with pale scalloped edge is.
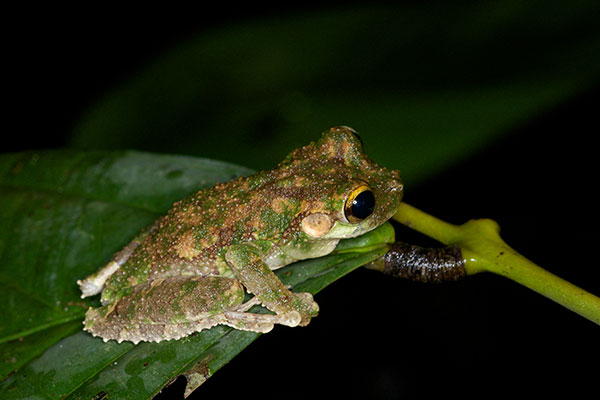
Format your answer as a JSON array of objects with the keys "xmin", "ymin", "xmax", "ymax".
[{"xmin": 84, "ymin": 276, "xmax": 300, "ymax": 343}]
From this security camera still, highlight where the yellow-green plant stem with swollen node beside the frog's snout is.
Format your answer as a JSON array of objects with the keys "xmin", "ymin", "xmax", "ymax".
[{"xmin": 393, "ymin": 203, "xmax": 600, "ymax": 325}]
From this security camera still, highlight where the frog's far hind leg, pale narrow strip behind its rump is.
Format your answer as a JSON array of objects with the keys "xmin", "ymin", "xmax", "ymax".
[{"xmin": 77, "ymin": 221, "xmax": 159, "ymax": 299}]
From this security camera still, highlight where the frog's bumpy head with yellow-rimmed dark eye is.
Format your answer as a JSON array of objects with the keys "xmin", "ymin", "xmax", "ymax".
[{"xmin": 279, "ymin": 126, "xmax": 403, "ymax": 239}]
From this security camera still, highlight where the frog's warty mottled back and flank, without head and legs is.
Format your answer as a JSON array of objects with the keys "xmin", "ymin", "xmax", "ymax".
[{"xmin": 102, "ymin": 171, "xmax": 301, "ymax": 303}]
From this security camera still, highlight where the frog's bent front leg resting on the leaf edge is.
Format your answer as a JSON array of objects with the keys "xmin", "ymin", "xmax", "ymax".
[{"xmin": 225, "ymin": 243, "xmax": 319, "ymax": 326}]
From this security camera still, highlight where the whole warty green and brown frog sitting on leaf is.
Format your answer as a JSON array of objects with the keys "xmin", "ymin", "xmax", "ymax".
[{"xmin": 78, "ymin": 127, "xmax": 402, "ymax": 343}]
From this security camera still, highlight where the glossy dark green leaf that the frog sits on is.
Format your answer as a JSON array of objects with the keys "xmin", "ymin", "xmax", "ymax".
[{"xmin": 0, "ymin": 150, "xmax": 394, "ymax": 399}]
